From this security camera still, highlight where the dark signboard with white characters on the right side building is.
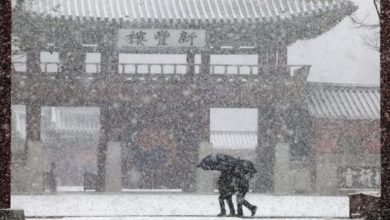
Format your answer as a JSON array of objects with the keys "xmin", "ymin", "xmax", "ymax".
[{"xmin": 338, "ymin": 167, "xmax": 381, "ymax": 189}]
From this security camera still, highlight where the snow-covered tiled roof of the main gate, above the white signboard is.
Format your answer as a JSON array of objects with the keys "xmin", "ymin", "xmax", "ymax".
[{"xmin": 24, "ymin": 0, "xmax": 353, "ymax": 22}]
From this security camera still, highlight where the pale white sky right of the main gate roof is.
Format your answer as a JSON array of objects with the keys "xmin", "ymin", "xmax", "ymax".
[{"xmin": 288, "ymin": 0, "xmax": 380, "ymax": 85}]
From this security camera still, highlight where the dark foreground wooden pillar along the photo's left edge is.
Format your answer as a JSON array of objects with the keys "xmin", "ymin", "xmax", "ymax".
[{"xmin": 0, "ymin": 1, "xmax": 11, "ymax": 209}]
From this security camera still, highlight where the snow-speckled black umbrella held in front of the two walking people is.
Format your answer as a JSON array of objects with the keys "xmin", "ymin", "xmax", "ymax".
[{"xmin": 196, "ymin": 154, "xmax": 239, "ymax": 172}]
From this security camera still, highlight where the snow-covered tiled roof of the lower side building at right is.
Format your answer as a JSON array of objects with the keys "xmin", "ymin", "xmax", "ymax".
[{"xmin": 307, "ymin": 83, "xmax": 380, "ymax": 120}]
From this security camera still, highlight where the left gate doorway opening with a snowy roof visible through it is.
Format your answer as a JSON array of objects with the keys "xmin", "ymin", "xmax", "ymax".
[{"xmin": 41, "ymin": 107, "xmax": 100, "ymax": 191}]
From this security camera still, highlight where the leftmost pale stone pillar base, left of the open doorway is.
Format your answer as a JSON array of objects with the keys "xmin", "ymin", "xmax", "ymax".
[{"xmin": 21, "ymin": 141, "xmax": 44, "ymax": 194}]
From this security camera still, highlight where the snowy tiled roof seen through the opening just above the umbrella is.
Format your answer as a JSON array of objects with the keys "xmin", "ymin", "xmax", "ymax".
[{"xmin": 210, "ymin": 131, "xmax": 257, "ymax": 149}]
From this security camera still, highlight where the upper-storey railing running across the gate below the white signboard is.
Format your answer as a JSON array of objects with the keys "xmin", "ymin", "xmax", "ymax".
[{"xmin": 13, "ymin": 62, "xmax": 310, "ymax": 77}]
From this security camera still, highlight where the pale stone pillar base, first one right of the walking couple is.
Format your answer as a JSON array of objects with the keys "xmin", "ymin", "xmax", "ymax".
[{"xmin": 274, "ymin": 143, "xmax": 293, "ymax": 194}]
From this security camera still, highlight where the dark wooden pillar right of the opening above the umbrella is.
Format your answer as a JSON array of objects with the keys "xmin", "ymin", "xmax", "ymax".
[{"xmin": 255, "ymin": 102, "xmax": 276, "ymax": 193}]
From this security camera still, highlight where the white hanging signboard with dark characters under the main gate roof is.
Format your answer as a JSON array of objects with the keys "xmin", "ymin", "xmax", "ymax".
[{"xmin": 118, "ymin": 29, "xmax": 206, "ymax": 48}]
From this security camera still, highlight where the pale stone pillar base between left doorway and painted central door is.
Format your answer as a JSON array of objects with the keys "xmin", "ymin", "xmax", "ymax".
[{"xmin": 105, "ymin": 142, "xmax": 122, "ymax": 192}]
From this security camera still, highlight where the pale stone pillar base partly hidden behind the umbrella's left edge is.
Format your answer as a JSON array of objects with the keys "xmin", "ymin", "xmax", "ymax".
[{"xmin": 196, "ymin": 142, "xmax": 214, "ymax": 193}]
